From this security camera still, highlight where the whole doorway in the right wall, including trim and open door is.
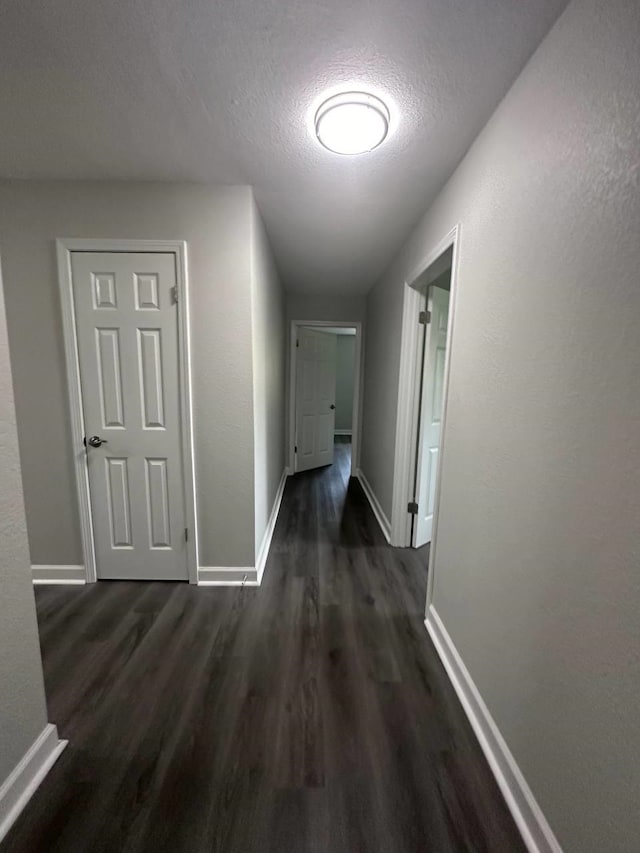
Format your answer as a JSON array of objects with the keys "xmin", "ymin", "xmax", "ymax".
[{"xmin": 392, "ymin": 223, "xmax": 457, "ymax": 563}]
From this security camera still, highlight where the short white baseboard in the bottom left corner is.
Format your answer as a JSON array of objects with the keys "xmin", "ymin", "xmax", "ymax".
[{"xmin": 0, "ymin": 723, "xmax": 67, "ymax": 841}]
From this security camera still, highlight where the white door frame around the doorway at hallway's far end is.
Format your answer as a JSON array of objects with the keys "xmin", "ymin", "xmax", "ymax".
[{"xmin": 287, "ymin": 320, "xmax": 364, "ymax": 477}]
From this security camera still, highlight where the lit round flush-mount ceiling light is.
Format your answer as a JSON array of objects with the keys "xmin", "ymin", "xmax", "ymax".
[{"xmin": 316, "ymin": 92, "xmax": 390, "ymax": 154}]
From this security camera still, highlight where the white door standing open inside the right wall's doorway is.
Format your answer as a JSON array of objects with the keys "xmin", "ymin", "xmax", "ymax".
[{"xmin": 411, "ymin": 287, "xmax": 449, "ymax": 548}]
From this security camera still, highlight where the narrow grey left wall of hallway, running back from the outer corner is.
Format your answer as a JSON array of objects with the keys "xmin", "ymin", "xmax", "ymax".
[{"xmin": 251, "ymin": 196, "xmax": 286, "ymax": 557}]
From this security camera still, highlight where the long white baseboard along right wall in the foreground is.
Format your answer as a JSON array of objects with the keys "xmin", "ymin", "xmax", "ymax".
[{"xmin": 425, "ymin": 605, "xmax": 562, "ymax": 853}]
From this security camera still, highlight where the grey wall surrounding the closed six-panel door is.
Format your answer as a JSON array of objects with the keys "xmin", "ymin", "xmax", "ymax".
[{"xmin": 0, "ymin": 181, "xmax": 255, "ymax": 566}]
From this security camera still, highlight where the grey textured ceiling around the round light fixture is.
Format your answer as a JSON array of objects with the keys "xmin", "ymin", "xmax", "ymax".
[{"xmin": 0, "ymin": 0, "xmax": 566, "ymax": 293}]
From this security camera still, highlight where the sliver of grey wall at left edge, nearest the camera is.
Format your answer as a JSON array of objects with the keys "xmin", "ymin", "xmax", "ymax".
[{"xmin": 0, "ymin": 258, "xmax": 47, "ymax": 788}]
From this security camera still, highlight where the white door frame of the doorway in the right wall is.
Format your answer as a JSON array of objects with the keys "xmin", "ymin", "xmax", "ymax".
[{"xmin": 391, "ymin": 225, "xmax": 460, "ymax": 609}]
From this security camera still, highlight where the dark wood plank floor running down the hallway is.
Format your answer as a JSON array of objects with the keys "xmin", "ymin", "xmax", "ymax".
[{"xmin": 1, "ymin": 443, "xmax": 524, "ymax": 853}]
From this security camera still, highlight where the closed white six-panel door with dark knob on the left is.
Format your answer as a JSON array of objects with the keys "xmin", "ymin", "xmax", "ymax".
[{"xmin": 71, "ymin": 252, "xmax": 187, "ymax": 580}]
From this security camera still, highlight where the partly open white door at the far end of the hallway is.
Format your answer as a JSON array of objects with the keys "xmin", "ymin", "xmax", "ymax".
[{"xmin": 295, "ymin": 328, "xmax": 336, "ymax": 471}]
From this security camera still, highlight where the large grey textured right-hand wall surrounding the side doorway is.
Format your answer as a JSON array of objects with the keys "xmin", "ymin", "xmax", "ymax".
[{"xmin": 361, "ymin": 0, "xmax": 640, "ymax": 853}]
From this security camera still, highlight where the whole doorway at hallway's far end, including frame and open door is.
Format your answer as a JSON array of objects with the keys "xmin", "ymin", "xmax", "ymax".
[{"xmin": 289, "ymin": 320, "xmax": 362, "ymax": 476}]
